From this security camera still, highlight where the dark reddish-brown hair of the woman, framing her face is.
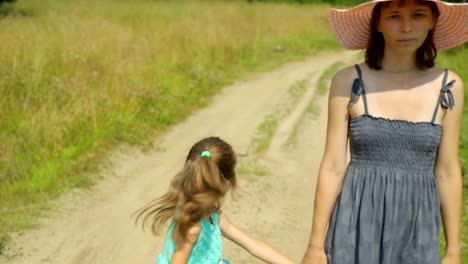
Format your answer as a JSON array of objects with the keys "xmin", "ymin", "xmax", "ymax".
[{"xmin": 366, "ymin": 0, "xmax": 440, "ymax": 70}]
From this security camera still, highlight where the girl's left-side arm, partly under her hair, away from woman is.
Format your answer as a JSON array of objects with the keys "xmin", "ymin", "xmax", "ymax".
[{"xmin": 171, "ymin": 223, "xmax": 201, "ymax": 264}]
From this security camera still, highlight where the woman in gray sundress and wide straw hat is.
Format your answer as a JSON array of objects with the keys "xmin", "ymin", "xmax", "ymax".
[{"xmin": 302, "ymin": 0, "xmax": 468, "ymax": 264}]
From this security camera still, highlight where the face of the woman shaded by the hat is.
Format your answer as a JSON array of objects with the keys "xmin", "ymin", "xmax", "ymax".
[{"xmin": 377, "ymin": 1, "xmax": 434, "ymax": 52}]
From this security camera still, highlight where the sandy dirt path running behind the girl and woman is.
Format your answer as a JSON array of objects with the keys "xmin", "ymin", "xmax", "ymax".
[{"xmin": 0, "ymin": 53, "xmax": 355, "ymax": 264}]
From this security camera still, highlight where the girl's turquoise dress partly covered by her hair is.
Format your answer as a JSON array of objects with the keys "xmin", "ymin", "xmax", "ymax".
[{"xmin": 156, "ymin": 212, "xmax": 230, "ymax": 264}]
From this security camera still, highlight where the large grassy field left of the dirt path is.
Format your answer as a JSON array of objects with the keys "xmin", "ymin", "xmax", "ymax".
[{"xmin": 0, "ymin": 0, "xmax": 338, "ymax": 251}]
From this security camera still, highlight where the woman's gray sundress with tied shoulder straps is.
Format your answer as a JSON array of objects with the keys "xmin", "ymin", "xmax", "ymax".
[{"xmin": 325, "ymin": 65, "xmax": 455, "ymax": 264}]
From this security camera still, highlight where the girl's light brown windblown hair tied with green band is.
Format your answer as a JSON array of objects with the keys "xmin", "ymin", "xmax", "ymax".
[{"xmin": 136, "ymin": 137, "xmax": 237, "ymax": 236}]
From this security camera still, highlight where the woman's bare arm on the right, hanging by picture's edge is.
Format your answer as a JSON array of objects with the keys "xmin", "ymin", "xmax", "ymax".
[{"xmin": 434, "ymin": 73, "xmax": 463, "ymax": 263}]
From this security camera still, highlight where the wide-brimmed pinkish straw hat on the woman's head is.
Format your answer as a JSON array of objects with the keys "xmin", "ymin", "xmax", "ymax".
[{"xmin": 328, "ymin": 0, "xmax": 468, "ymax": 50}]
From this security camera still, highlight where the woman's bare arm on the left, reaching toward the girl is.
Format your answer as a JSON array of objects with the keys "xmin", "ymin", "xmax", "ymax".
[{"xmin": 302, "ymin": 67, "xmax": 352, "ymax": 264}]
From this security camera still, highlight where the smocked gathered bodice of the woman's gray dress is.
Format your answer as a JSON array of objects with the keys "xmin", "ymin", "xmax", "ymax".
[{"xmin": 349, "ymin": 115, "xmax": 442, "ymax": 170}]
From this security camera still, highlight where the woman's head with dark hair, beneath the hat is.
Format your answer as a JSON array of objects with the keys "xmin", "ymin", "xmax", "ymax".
[{"xmin": 366, "ymin": 0, "xmax": 439, "ymax": 69}]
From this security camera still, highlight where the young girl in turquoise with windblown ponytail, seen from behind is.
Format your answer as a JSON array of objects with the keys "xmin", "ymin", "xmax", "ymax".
[{"xmin": 137, "ymin": 137, "xmax": 293, "ymax": 264}]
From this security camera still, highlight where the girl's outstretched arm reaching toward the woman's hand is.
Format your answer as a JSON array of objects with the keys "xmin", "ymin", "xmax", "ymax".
[{"xmin": 219, "ymin": 212, "xmax": 294, "ymax": 264}]
